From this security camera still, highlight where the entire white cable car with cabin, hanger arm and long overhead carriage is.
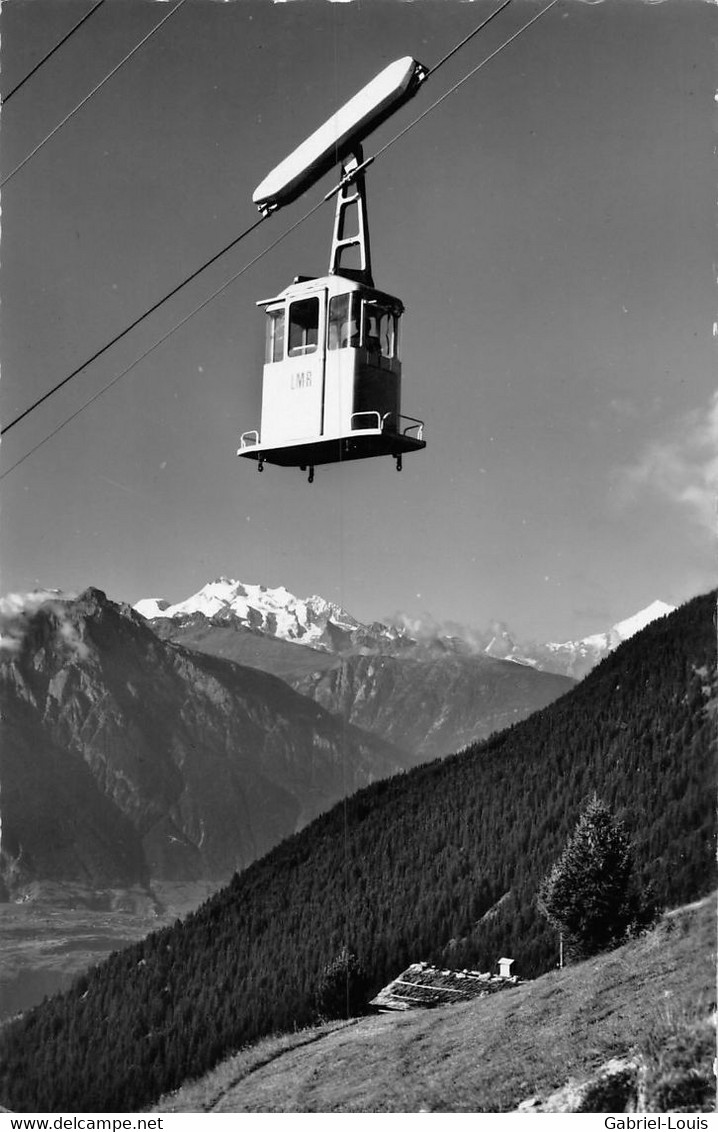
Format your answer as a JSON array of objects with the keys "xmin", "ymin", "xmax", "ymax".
[{"xmin": 238, "ymin": 59, "xmax": 426, "ymax": 480}]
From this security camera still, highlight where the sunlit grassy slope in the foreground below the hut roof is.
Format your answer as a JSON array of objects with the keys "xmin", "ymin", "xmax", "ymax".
[{"xmin": 153, "ymin": 897, "xmax": 716, "ymax": 1113}]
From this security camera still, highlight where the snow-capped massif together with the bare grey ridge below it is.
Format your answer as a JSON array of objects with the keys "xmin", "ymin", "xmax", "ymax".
[{"xmin": 135, "ymin": 578, "xmax": 573, "ymax": 760}]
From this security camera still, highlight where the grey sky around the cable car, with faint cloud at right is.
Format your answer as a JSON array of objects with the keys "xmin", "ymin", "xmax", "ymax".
[{"xmin": 0, "ymin": 0, "xmax": 718, "ymax": 640}]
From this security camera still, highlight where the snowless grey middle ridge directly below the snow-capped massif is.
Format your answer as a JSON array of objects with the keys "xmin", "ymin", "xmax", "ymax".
[{"xmin": 133, "ymin": 611, "xmax": 573, "ymax": 760}]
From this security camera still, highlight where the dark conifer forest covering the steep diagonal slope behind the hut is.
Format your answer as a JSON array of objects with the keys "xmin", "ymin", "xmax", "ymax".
[{"xmin": 0, "ymin": 594, "xmax": 717, "ymax": 1112}]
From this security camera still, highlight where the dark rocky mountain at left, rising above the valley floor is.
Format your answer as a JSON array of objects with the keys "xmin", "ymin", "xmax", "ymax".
[{"xmin": 0, "ymin": 589, "xmax": 416, "ymax": 892}]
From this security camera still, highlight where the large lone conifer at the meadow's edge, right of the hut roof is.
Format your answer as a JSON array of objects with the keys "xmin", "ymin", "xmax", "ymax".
[{"xmin": 538, "ymin": 796, "xmax": 653, "ymax": 959}]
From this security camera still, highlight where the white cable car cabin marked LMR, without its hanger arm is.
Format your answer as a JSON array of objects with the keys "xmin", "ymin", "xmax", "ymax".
[{"xmin": 237, "ymin": 275, "xmax": 426, "ymax": 479}]
